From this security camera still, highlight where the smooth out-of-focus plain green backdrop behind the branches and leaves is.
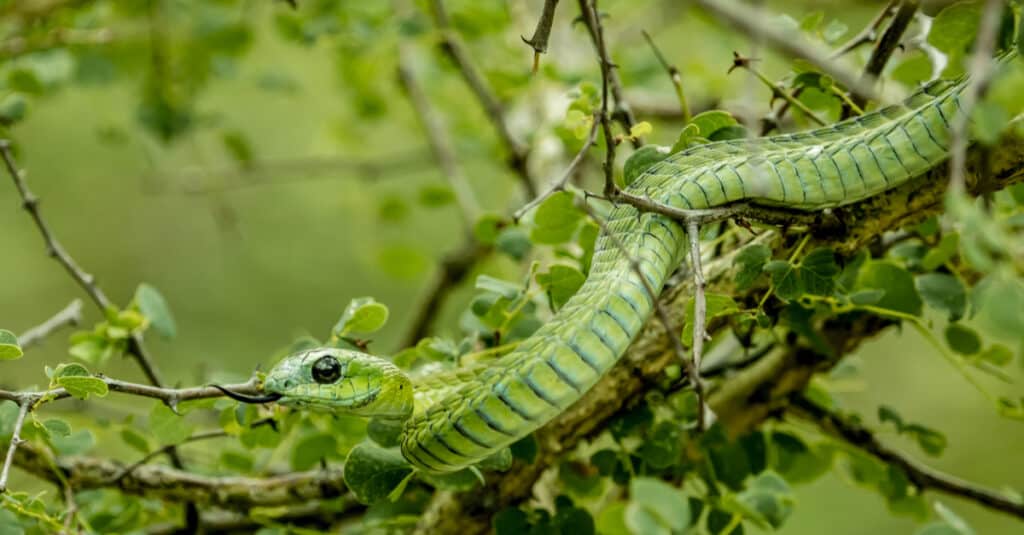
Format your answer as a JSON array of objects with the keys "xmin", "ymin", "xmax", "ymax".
[{"xmin": 0, "ymin": 0, "xmax": 1024, "ymax": 534}]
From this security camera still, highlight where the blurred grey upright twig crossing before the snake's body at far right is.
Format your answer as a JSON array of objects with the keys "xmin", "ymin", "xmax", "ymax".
[{"xmin": 949, "ymin": 0, "xmax": 1002, "ymax": 195}]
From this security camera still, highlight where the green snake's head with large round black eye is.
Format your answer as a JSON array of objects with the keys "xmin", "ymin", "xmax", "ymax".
[{"xmin": 263, "ymin": 347, "xmax": 413, "ymax": 419}]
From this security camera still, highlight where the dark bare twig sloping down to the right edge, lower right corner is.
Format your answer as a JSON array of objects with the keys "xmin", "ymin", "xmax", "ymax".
[{"xmin": 792, "ymin": 395, "xmax": 1024, "ymax": 519}]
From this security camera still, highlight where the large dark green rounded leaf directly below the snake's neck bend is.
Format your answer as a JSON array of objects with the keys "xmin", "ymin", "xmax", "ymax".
[{"xmin": 343, "ymin": 442, "xmax": 413, "ymax": 504}]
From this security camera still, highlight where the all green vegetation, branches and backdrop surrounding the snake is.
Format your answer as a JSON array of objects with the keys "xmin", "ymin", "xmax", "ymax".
[{"xmin": 0, "ymin": 0, "xmax": 1024, "ymax": 535}]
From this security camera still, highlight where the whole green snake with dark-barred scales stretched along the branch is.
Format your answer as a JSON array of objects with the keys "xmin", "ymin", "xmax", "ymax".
[{"xmin": 218, "ymin": 52, "xmax": 1015, "ymax": 472}]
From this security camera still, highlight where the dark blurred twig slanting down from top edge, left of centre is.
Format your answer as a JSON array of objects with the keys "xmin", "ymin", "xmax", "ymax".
[{"xmin": 430, "ymin": 0, "xmax": 537, "ymax": 199}]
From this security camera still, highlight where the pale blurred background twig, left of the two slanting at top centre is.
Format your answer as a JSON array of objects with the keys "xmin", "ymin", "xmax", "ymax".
[{"xmin": 398, "ymin": 45, "xmax": 480, "ymax": 223}]
